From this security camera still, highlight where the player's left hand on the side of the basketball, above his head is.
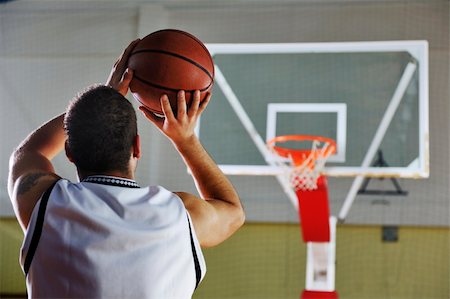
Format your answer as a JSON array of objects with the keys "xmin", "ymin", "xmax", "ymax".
[{"xmin": 106, "ymin": 39, "xmax": 140, "ymax": 96}]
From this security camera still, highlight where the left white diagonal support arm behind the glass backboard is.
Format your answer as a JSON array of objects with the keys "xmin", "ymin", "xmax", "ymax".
[{"xmin": 215, "ymin": 65, "xmax": 298, "ymax": 210}]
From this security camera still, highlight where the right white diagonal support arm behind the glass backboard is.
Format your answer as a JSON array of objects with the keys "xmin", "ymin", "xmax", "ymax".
[{"xmin": 338, "ymin": 61, "xmax": 417, "ymax": 222}]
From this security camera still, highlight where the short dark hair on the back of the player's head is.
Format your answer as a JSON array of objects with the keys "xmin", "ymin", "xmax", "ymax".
[{"xmin": 64, "ymin": 85, "xmax": 137, "ymax": 173}]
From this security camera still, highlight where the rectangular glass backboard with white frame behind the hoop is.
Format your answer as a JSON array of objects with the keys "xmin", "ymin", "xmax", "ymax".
[{"xmin": 197, "ymin": 41, "xmax": 429, "ymax": 178}]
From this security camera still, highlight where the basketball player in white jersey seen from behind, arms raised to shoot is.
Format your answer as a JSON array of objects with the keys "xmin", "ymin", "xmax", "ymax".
[{"xmin": 8, "ymin": 41, "xmax": 244, "ymax": 299}]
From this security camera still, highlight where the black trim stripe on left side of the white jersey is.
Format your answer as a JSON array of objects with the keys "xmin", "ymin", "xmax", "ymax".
[{"xmin": 23, "ymin": 180, "xmax": 59, "ymax": 275}]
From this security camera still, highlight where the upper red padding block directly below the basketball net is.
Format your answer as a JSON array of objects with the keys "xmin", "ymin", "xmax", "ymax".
[{"xmin": 296, "ymin": 176, "xmax": 330, "ymax": 243}]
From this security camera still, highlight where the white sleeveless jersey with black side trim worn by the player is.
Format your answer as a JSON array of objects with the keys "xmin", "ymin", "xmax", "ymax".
[{"xmin": 20, "ymin": 176, "xmax": 206, "ymax": 299}]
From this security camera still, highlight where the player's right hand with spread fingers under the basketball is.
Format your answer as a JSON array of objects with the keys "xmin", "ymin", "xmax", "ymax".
[{"xmin": 139, "ymin": 90, "xmax": 211, "ymax": 147}]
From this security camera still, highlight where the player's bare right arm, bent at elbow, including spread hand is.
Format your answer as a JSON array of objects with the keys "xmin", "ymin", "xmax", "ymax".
[{"xmin": 140, "ymin": 91, "xmax": 245, "ymax": 247}]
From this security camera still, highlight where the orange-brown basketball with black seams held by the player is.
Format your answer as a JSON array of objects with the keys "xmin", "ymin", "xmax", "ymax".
[{"xmin": 128, "ymin": 29, "xmax": 214, "ymax": 114}]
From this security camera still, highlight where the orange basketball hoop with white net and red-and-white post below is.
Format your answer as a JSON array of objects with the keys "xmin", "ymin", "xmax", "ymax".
[{"xmin": 267, "ymin": 135, "xmax": 337, "ymax": 298}]
